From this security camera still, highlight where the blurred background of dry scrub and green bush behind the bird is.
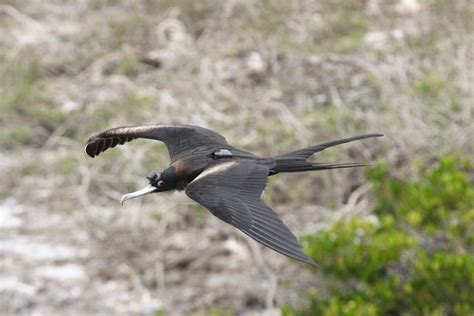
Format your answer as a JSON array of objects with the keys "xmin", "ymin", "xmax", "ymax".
[{"xmin": 0, "ymin": 0, "xmax": 474, "ymax": 315}]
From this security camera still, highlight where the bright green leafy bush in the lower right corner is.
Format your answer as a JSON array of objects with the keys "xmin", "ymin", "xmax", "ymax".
[{"xmin": 282, "ymin": 155, "xmax": 474, "ymax": 316}]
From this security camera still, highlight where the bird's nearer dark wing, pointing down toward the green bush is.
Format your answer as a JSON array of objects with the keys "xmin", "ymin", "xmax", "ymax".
[{"xmin": 186, "ymin": 161, "xmax": 315, "ymax": 265}]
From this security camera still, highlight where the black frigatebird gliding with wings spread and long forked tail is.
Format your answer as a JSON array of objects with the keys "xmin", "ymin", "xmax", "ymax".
[{"xmin": 85, "ymin": 124, "xmax": 382, "ymax": 265}]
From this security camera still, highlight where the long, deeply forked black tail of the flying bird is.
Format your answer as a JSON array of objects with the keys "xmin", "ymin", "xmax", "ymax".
[{"xmin": 272, "ymin": 134, "xmax": 383, "ymax": 174}]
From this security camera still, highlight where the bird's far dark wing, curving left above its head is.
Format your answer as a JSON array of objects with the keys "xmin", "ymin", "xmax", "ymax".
[{"xmin": 86, "ymin": 124, "xmax": 228, "ymax": 161}]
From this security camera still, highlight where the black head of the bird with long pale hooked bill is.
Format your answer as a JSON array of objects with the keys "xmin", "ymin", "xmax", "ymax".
[{"xmin": 120, "ymin": 169, "xmax": 176, "ymax": 205}]
